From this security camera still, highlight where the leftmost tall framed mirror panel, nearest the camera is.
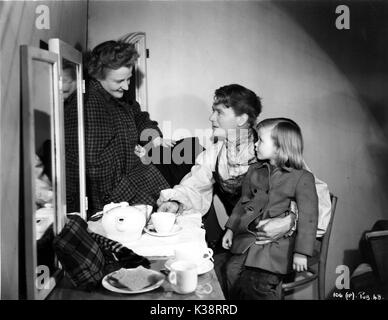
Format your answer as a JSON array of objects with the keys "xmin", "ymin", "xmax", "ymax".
[{"xmin": 21, "ymin": 46, "xmax": 66, "ymax": 299}]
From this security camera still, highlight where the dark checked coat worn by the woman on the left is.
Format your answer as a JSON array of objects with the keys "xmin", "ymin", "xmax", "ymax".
[{"xmin": 67, "ymin": 80, "xmax": 169, "ymax": 216}]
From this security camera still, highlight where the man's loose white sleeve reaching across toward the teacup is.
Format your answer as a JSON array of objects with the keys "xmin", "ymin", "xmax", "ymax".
[{"xmin": 157, "ymin": 145, "xmax": 219, "ymax": 216}]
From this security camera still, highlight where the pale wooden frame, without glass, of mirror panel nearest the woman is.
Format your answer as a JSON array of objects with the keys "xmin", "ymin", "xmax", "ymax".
[{"xmin": 49, "ymin": 38, "xmax": 87, "ymax": 221}]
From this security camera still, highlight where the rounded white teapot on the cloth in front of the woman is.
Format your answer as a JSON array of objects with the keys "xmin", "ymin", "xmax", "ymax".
[{"xmin": 101, "ymin": 202, "xmax": 152, "ymax": 243}]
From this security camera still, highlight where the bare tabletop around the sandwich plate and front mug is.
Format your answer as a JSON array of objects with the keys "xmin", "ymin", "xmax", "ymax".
[{"xmin": 47, "ymin": 257, "xmax": 225, "ymax": 300}]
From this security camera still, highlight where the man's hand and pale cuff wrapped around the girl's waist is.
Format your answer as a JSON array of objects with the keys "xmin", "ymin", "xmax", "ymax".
[{"xmin": 256, "ymin": 214, "xmax": 295, "ymax": 240}]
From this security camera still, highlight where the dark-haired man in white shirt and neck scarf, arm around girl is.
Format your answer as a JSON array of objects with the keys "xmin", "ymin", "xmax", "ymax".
[{"xmin": 157, "ymin": 84, "xmax": 330, "ymax": 293}]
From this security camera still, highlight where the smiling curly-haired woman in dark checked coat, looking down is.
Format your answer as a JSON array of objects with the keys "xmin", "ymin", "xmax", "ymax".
[{"xmin": 81, "ymin": 41, "xmax": 173, "ymax": 216}]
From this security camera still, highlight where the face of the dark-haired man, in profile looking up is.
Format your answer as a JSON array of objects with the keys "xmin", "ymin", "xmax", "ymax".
[{"xmin": 209, "ymin": 104, "xmax": 239, "ymax": 137}]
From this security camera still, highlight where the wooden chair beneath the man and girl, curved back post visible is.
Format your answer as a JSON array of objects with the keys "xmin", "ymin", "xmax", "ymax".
[{"xmin": 280, "ymin": 194, "xmax": 338, "ymax": 300}]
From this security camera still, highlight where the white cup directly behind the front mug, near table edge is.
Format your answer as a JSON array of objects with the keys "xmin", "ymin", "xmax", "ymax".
[{"xmin": 175, "ymin": 243, "xmax": 213, "ymax": 267}]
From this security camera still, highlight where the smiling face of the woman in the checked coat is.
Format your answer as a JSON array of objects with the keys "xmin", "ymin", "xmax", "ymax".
[{"xmin": 98, "ymin": 67, "xmax": 132, "ymax": 99}]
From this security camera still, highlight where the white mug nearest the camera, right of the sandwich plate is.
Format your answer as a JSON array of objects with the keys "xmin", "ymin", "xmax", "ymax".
[{"xmin": 168, "ymin": 260, "xmax": 198, "ymax": 294}]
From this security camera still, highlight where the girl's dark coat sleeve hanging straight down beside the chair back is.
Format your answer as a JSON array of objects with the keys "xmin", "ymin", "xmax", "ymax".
[{"xmin": 294, "ymin": 171, "xmax": 318, "ymax": 256}]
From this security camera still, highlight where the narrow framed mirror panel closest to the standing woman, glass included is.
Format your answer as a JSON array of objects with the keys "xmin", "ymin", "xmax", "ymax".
[{"xmin": 49, "ymin": 39, "xmax": 87, "ymax": 220}]
